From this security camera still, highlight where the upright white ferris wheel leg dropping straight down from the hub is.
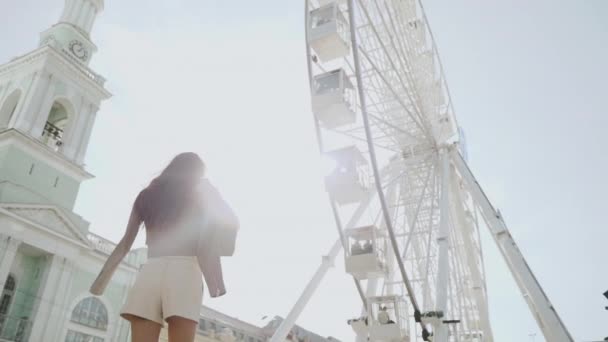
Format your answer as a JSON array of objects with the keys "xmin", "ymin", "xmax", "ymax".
[{"xmin": 433, "ymin": 147, "xmax": 450, "ymax": 342}]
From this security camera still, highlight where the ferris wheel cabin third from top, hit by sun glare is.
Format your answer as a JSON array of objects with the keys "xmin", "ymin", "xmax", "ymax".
[{"xmin": 325, "ymin": 146, "xmax": 370, "ymax": 204}]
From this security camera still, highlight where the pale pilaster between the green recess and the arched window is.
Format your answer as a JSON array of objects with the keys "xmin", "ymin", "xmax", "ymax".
[{"xmin": 30, "ymin": 255, "xmax": 66, "ymax": 341}]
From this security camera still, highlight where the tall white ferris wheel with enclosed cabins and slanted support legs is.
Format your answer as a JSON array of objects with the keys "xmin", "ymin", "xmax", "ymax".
[{"xmin": 271, "ymin": 0, "xmax": 573, "ymax": 342}]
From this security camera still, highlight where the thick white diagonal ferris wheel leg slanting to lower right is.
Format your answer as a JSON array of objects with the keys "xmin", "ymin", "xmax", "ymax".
[{"xmin": 451, "ymin": 149, "xmax": 574, "ymax": 342}]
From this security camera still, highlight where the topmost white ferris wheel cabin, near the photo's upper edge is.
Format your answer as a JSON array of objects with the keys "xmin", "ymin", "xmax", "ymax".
[{"xmin": 308, "ymin": 1, "xmax": 350, "ymax": 62}]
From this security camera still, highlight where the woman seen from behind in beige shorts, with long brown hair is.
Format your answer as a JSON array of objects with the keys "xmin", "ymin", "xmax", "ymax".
[{"xmin": 91, "ymin": 153, "xmax": 238, "ymax": 342}]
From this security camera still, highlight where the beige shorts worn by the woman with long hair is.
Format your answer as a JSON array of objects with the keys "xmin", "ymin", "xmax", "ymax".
[{"xmin": 120, "ymin": 256, "xmax": 203, "ymax": 326}]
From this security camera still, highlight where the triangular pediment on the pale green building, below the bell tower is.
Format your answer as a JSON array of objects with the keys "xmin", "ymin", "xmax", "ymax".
[{"xmin": 0, "ymin": 204, "xmax": 89, "ymax": 245}]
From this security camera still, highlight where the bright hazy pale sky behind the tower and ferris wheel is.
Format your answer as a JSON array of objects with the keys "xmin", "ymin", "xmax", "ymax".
[{"xmin": 0, "ymin": 0, "xmax": 608, "ymax": 341}]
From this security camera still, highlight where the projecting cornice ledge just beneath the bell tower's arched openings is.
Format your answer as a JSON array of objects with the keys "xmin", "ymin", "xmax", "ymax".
[{"xmin": 0, "ymin": 128, "xmax": 94, "ymax": 182}]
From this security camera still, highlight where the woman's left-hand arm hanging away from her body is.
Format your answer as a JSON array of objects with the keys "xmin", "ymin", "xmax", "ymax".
[{"xmin": 90, "ymin": 205, "xmax": 142, "ymax": 296}]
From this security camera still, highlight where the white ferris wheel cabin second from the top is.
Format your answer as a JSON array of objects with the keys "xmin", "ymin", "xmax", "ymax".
[{"xmin": 312, "ymin": 69, "xmax": 356, "ymax": 129}]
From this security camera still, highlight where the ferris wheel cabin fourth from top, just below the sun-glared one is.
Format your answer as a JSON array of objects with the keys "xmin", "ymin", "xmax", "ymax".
[{"xmin": 344, "ymin": 226, "xmax": 388, "ymax": 280}]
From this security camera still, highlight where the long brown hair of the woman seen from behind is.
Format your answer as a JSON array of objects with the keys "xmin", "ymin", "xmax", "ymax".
[{"xmin": 134, "ymin": 152, "xmax": 205, "ymax": 229}]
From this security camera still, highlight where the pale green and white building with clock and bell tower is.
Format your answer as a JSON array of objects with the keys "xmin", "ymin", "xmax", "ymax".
[{"xmin": 0, "ymin": 0, "xmax": 153, "ymax": 342}]
